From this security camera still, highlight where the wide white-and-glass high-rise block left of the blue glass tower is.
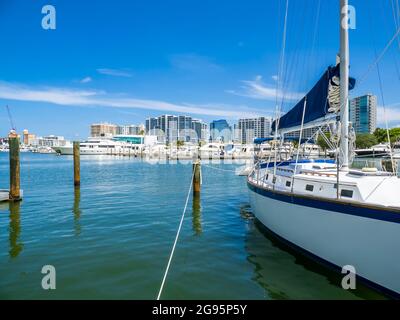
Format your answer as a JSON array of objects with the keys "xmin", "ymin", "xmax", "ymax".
[{"xmin": 146, "ymin": 114, "xmax": 207, "ymax": 143}]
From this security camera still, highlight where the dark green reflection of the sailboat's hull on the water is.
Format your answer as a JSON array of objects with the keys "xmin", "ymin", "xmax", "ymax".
[{"xmin": 240, "ymin": 206, "xmax": 385, "ymax": 299}]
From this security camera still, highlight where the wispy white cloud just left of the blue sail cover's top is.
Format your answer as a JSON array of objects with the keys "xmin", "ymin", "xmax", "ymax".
[{"xmin": 227, "ymin": 75, "xmax": 304, "ymax": 101}]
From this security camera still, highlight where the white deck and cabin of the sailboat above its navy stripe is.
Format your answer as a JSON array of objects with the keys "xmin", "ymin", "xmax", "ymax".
[{"xmin": 249, "ymin": 162, "xmax": 400, "ymax": 209}]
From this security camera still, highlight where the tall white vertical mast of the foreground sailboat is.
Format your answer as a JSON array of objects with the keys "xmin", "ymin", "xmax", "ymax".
[{"xmin": 340, "ymin": 0, "xmax": 350, "ymax": 170}]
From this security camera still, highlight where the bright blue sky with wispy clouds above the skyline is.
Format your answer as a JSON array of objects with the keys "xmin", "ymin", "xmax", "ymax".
[{"xmin": 0, "ymin": 0, "xmax": 400, "ymax": 138}]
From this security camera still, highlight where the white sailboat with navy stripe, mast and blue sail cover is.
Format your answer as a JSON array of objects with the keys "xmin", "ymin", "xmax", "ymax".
[{"xmin": 247, "ymin": 0, "xmax": 400, "ymax": 297}]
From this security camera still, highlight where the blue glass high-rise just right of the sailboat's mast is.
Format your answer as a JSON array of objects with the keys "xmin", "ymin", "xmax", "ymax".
[{"xmin": 349, "ymin": 94, "xmax": 378, "ymax": 133}]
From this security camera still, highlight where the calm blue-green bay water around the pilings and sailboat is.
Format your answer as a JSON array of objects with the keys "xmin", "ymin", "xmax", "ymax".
[{"xmin": 0, "ymin": 154, "xmax": 388, "ymax": 299}]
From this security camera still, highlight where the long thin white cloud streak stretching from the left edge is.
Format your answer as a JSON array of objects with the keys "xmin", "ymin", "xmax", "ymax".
[{"xmin": 0, "ymin": 82, "xmax": 264, "ymax": 118}]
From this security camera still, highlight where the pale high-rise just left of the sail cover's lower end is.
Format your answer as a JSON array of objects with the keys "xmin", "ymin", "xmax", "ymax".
[{"xmin": 238, "ymin": 117, "xmax": 272, "ymax": 143}]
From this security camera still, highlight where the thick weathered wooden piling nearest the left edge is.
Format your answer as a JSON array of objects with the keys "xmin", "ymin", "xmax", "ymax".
[{"xmin": 8, "ymin": 135, "xmax": 21, "ymax": 201}]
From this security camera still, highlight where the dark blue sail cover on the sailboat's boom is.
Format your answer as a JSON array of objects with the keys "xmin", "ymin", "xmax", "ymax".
[{"xmin": 272, "ymin": 64, "xmax": 356, "ymax": 131}]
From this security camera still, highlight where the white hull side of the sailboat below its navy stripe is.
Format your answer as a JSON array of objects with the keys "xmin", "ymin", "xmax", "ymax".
[{"xmin": 249, "ymin": 185, "xmax": 400, "ymax": 296}]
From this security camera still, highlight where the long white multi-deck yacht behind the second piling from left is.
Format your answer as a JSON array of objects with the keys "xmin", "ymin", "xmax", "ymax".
[{"xmin": 52, "ymin": 138, "xmax": 142, "ymax": 155}]
